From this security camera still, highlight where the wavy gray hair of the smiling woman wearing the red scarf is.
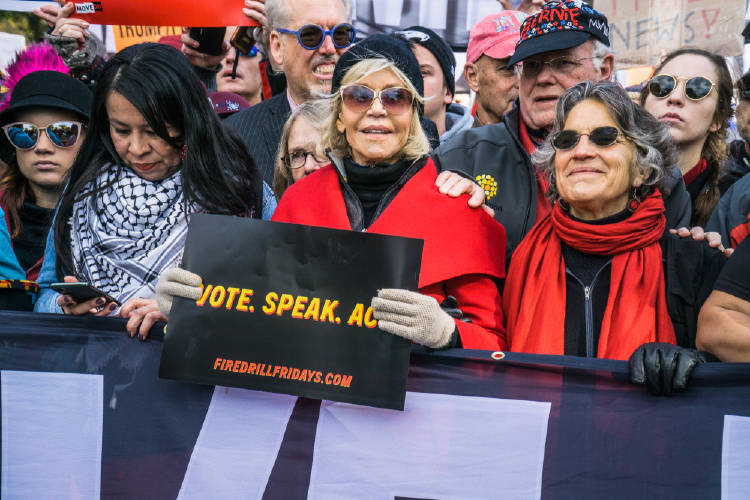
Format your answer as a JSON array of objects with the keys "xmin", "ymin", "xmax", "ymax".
[{"xmin": 531, "ymin": 82, "xmax": 677, "ymax": 202}]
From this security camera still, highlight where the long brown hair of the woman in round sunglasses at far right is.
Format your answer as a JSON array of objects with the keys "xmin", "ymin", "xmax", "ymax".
[{"xmin": 640, "ymin": 47, "xmax": 733, "ymax": 226}]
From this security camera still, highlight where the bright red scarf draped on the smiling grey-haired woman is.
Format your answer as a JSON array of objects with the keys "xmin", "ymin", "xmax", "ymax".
[{"xmin": 503, "ymin": 191, "xmax": 676, "ymax": 359}]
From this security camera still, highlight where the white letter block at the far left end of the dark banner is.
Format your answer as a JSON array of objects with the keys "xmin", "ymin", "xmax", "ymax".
[{"xmin": 0, "ymin": 370, "xmax": 104, "ymax": 500}]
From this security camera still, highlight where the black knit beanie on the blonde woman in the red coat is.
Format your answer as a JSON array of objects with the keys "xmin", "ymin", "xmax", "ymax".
[{"xmin": 331, "ymin": 34, "xmax": 424, "ymax": 114}]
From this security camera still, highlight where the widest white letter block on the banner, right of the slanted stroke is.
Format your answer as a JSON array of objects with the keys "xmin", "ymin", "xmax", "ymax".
[{"xmin": 308, "ymin": 392, "xmax": 551, "ymax": 500}]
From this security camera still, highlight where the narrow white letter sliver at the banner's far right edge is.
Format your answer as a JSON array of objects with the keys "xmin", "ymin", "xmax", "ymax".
[{"xmin": 721, "ymin": 415, "xmax": 750, "ymax": 500}]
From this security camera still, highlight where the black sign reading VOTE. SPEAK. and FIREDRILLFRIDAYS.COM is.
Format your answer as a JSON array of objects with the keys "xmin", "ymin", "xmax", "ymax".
[{"xmin": 159, "ymin": 214, "xmax": 422, "ymax": 409}]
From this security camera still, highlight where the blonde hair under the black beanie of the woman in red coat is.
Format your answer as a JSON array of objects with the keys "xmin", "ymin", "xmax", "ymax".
[{"xmin": 322, "ymin": 57, "xmax": 430, "ymax": 161}]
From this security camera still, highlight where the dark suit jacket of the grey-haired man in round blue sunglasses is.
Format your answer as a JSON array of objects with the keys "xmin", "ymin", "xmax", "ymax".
[{"xmin": 224, "ymin": 92, "xmax": 292, "ymax": 186}]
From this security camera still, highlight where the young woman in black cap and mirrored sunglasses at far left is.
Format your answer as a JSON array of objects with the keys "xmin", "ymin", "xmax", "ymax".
[{"xmin": 0, "ymin": 71, "xmax": 91, "ymax": 281}]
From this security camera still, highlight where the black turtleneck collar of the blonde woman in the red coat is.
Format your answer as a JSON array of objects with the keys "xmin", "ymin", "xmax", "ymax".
[{"xmin": 344, "ymin": 158, "xmax": 412, "ymax": 227}]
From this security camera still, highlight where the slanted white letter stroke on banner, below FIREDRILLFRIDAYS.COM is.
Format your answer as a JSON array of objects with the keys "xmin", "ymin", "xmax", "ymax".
[{"xmin": 177, "ymin": 386, "xmax": 297, "ymax": 500}]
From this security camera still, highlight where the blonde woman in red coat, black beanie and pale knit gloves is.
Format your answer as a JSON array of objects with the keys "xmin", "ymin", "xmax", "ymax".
[{"xmin": 158, "ymin": 35, "xmax": 505, "ymax": 350}]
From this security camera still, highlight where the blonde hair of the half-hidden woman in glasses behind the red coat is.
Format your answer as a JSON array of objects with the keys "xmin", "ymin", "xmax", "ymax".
[{"xmin": 273, "ymin": 99, "xmax": 330, "ymax": 200}]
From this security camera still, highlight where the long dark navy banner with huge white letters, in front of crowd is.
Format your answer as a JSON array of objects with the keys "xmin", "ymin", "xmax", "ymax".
[{"xmin": 0, "ymin": 311, "xmax": 750, "ymax": 500}]
